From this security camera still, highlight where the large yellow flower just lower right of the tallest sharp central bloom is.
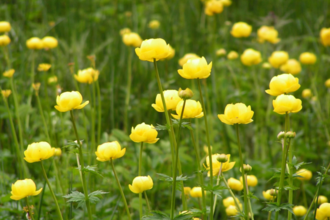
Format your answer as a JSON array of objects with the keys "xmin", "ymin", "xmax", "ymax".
[{"xmin": 178, "ymin": 57, "xmax": 212, "ymax": 79}]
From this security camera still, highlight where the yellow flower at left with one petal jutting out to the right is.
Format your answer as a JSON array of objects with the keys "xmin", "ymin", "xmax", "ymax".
[{"xmin": 55, "ymin": 91, "xmax": 89, "ymax": 112}]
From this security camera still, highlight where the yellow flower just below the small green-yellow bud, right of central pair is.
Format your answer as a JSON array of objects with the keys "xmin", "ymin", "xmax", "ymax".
[{"xmin": 172, "ymin": 99, "xmax": 204, "ymax": 119}]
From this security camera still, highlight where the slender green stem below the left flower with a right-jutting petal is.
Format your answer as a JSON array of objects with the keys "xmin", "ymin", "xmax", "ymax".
[{"xmin": 70, "ymin": 110, "xmax": 92, "ymax": 220}]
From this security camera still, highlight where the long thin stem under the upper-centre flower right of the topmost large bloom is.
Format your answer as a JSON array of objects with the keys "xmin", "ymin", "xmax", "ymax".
[{"xmin": 197, "ymin": 79, "xmax": 213, "ymax": 220}]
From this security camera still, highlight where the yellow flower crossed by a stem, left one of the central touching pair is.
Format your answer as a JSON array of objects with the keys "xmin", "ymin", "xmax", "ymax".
[{"xmin": 151, "ymin": 90, "xmax": 182, "ymax": 112}]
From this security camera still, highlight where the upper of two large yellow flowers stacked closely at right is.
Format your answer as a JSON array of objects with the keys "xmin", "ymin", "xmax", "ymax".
[{"xmin": 266, "ymin": 73, "xmax": 300, "ymax": 96}]
